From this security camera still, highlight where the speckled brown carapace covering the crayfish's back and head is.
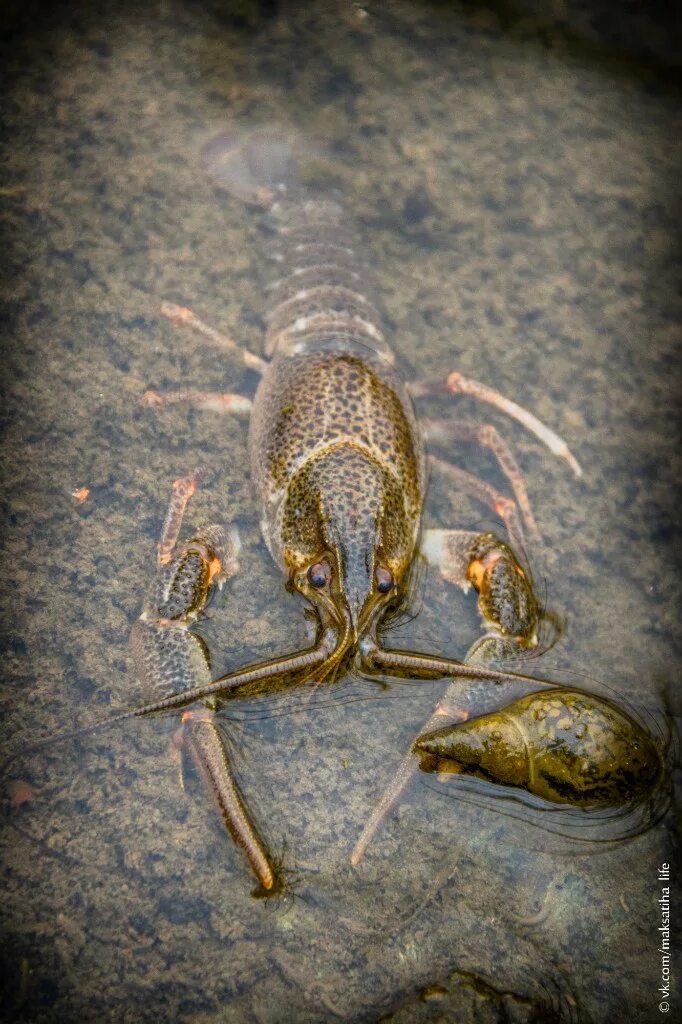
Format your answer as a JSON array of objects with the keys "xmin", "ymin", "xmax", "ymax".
[{"xmin": 250, "ymin": 350, "xmax": 424, "ymax": 573}]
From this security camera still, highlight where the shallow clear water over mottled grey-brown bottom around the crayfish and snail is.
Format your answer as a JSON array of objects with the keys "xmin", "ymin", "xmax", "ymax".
[{"xmin": 0, "ymin": 2, "xmax": 682, "ymax": 1024}]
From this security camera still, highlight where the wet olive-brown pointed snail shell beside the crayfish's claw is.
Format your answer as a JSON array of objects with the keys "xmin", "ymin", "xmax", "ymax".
[{"xmin": 415, "ymin": 688, "xmax": 663, "ymax": 807}]
